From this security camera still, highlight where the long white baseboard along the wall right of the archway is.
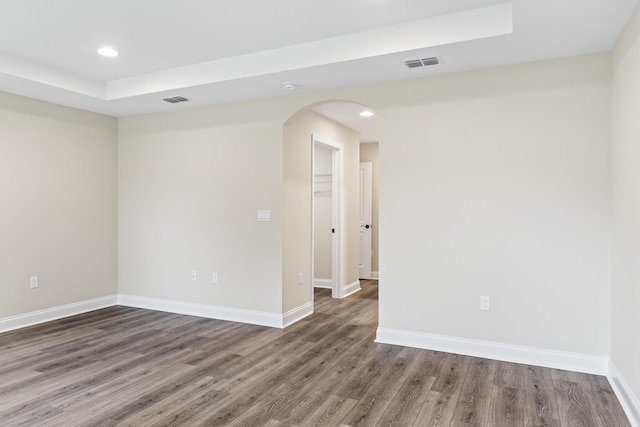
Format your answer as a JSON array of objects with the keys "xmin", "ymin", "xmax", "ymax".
[{"xmin": 376, "ymin": 328, "xmax": 609, "ymax": 375}]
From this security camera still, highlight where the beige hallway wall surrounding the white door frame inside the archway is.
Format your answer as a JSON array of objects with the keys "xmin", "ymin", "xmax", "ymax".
[{"xmin": 283, "ymin": 111, "xmax": 360, "ymax": 312}]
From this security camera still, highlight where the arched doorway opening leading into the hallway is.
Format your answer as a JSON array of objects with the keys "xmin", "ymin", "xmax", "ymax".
[{"xmin": 283, "ymin": 101, "xmax": 378, "ymax": 324}]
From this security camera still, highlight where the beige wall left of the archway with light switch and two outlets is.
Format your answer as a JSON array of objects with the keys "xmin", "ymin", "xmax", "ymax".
[{"xmin": 118, "ymin": 106, "xmax": 283, "ymax": 314}]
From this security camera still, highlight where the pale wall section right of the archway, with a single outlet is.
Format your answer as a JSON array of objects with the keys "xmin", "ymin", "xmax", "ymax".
[{"xmin": 377, "ymin": 56, "xmax": 611, "ymax": 356}]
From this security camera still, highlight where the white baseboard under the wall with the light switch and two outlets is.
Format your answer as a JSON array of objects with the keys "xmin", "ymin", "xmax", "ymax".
[{"xmin": 118, "ymin": 294, "xmax": 284, "ymax": 328}]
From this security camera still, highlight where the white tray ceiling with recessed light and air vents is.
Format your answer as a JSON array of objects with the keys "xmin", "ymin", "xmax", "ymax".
[{"xmin": 0, "ymin": 0, "xmax": 639, "ymax": 140}]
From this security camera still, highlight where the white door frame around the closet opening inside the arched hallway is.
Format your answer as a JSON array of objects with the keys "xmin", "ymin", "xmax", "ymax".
[{"xmin": 310, "ymin": 134, "xmax": 344, "ymax": 302}]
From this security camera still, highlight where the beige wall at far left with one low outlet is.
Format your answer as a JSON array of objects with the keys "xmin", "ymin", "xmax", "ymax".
[{"xmin": 0, "ymin": 93, "xmax": 117, "ymax": 318}]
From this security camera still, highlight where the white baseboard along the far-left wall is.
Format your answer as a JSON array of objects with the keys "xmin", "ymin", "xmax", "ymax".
[{"xmin": 0, "ymin": 295, "xmax": 117, "ymax": 332}]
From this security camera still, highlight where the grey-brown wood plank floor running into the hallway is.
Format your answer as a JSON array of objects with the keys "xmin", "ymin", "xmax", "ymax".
[{"xmin": 0, "ymin": 281, "xmax": 630, "ymax": 427}]
